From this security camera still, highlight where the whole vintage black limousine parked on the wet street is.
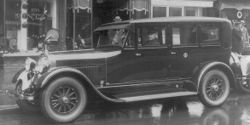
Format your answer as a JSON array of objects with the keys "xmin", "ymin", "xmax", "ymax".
[{"xmin": 13, "ymin": 17, "xmax": 249, "ymax": 122}]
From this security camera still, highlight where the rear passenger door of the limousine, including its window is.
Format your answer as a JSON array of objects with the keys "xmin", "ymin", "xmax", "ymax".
[{"xmin": 171, "ymin": 23, "xmax": 202, "ymax": 78}]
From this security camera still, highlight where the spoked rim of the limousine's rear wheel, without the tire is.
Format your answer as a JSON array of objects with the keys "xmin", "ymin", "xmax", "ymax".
[{"xmin": 206, "ymin": 75, "xmax": 225, "ymax": 101}]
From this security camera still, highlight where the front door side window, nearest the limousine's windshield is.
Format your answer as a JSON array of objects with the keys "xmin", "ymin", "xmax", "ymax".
[{"xmin": 136, "ymin": 26, "xmax": 166, "ymax": 47}]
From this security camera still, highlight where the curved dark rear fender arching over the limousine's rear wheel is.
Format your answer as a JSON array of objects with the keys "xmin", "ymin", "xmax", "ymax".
[{"xmin": 197, "ymin": 61, "xmax": 235, "ymax": 92}]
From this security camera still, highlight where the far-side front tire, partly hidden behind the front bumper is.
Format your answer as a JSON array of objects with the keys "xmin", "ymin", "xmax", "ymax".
[{"xmin": 15, "ymin": 83, "xmax": 40, "ymax": 112}]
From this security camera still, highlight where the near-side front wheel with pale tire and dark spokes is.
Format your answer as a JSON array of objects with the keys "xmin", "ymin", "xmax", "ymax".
[{"xmin": 41, "ymin": 77, "xmax": 87, "ymax": 123}]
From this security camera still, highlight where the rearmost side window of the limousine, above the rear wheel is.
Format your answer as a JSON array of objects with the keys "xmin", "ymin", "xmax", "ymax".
[{"xmin": 199, "ymin": 23, "xmax": 220, "ymax": 44}]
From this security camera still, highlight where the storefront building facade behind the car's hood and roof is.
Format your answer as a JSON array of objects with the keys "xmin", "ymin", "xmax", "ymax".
[{"xmin": 0, "ymin": 0, "xmax": 218, "ymax": 52}]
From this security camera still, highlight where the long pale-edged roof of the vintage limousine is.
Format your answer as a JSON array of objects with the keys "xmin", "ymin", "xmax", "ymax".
[{"xmin": 95, "ymin": 16, "xmax": 231, "ymax": 31}]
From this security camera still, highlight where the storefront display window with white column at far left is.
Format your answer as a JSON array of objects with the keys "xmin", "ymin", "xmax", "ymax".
[{"xmin": 3, "ymin": 0, "xmax": 65, "ymax": 52}]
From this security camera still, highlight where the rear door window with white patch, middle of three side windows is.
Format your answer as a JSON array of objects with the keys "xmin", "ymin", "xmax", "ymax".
[{"xmin": 171, "ymin": 24, "xmax": 198, "ymax": 46}]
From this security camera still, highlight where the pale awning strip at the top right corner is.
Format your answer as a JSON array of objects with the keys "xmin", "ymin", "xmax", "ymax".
[{"xmin": 219, "ymin": 1, "xmax": 250, "ymax": 10}]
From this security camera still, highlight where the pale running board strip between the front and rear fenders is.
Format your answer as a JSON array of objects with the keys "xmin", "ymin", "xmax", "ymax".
[{"xmin": 119, "ymin": 92, "xmax": 197, "ymax": 102}]
